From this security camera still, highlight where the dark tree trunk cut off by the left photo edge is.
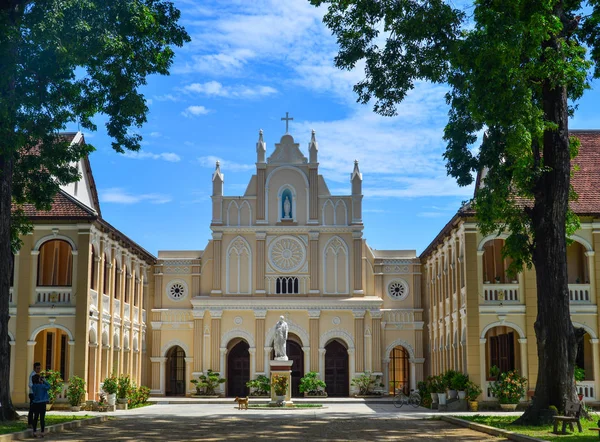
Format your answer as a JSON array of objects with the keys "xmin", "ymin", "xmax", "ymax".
[{"xmin": 0, "ymin": 152, "xmax": 18, "ymax": 421}]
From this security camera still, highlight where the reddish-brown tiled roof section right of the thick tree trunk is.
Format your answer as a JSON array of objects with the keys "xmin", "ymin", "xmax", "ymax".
[{"xmin": 570, "ymin": 130, "xmax": 600, "ymax": 215}]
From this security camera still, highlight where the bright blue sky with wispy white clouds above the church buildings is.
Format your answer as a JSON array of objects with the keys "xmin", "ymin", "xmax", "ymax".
[{"xmin": 74, "ymin": 0, "xmax": 600, "ymax": 254}]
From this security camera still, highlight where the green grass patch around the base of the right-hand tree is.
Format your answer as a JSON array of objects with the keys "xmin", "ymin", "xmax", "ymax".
[{"xmin": 452, "ymin": 413, "xmax": 600, "ymax": 442}]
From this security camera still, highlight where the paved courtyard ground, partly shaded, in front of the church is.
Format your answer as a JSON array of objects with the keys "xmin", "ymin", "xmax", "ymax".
[{"xmin": 39, "ymin": 404, "xmax": 505, "ymax": 442}]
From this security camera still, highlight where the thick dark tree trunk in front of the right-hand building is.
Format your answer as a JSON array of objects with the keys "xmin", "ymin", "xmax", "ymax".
[{"xmin": 515, "ymin": 64, "xmax": 577, "ymax": 425}]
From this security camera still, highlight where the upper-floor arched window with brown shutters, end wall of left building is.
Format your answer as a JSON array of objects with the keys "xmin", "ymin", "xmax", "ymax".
[{"xmin": 37, "ymin": 239, "xmax": 73, "ymax": 287}]
